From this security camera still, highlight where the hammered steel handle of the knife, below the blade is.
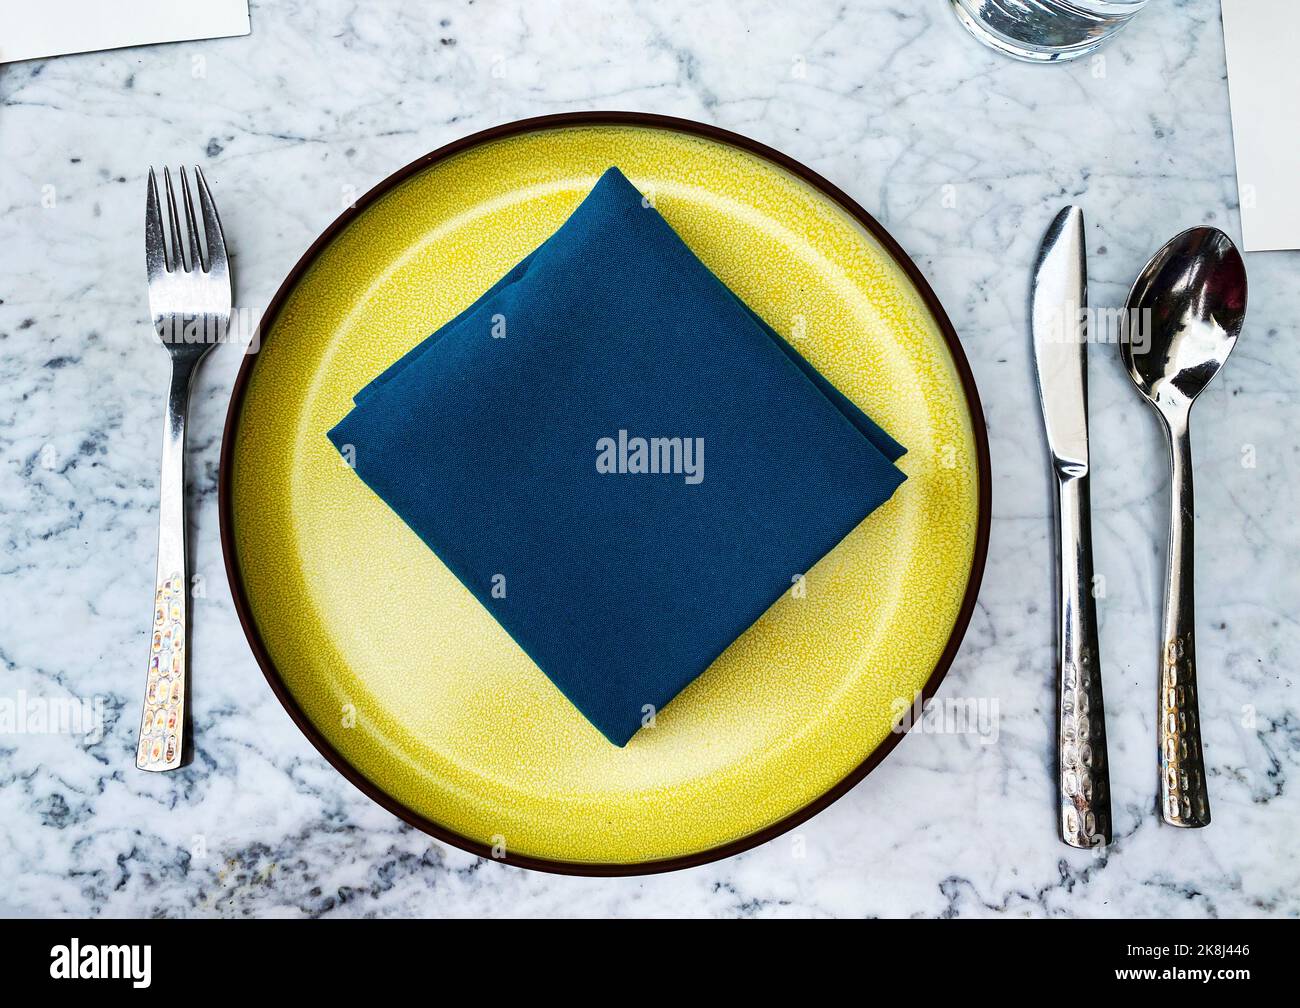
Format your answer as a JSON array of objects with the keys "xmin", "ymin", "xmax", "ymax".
[{"xmin": 1056, "ymin": 472, "xmax": 1110, "ymax": 848}]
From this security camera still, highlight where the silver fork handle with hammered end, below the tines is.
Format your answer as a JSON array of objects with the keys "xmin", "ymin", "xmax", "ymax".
[{"xmin": 135, "ymin": 358, "xmax": 195, "ymax": 770}]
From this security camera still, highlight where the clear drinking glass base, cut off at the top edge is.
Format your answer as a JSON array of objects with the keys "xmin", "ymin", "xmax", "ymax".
[{"xmin": 949, "ymin": 0, "xmax": 1147, "ymax": 62}]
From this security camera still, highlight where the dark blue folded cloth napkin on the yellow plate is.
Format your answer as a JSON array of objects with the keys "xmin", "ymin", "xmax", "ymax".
[{"xmin": 329, "ymin": 168, "xmax": 905, "ymax": 745}]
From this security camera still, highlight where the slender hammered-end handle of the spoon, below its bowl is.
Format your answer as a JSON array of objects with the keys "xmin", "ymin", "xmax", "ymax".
[{"xmin": 1158, "ymin": 411, "xmax": 1210, "ymax": 827}]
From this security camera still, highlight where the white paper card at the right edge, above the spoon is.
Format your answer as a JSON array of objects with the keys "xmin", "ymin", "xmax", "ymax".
[{"xmin": 1223, "ymin": 0, "xmax": 1300, "ymax": 252}]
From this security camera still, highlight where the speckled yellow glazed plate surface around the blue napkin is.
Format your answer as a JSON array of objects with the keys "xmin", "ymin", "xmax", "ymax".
[{"xmin": 231, "ymin": 126, "xmax": 978, "ymax": 864}]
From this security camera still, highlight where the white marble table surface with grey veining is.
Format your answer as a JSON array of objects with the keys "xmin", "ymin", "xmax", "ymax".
[{"xmin": 0, "ymin": 0, "xmax": 1300, "ymax": 917}]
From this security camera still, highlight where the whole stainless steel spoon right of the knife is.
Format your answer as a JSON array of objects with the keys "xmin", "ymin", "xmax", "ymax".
[{"xmin": 1119, "ymin": 228, "xmax": 1245, "ymax": 827}]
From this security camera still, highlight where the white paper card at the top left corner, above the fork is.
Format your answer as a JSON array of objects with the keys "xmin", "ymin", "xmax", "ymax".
[{"xmin": 0, "ymin": 0, "xmax": 248, "ymax": 62}]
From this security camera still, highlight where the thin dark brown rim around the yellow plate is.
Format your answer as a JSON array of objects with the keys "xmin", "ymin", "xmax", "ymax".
[{"xmin": 217, "ymin": 112, "xmax": 992, "ymax": 877}]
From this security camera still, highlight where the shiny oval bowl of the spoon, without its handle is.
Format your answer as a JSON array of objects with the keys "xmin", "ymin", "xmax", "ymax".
[{"xmin": 1121, "ymin": 228, "xmax": 1245, "ymax": 414}]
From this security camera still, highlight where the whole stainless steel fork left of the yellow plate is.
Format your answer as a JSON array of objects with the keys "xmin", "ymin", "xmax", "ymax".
[{"xmin": 135, "ymin": 166, "xmax": 230, "ymax": 770}]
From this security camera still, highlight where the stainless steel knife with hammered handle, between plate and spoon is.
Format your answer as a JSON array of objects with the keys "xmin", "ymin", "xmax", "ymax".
[{"xmin": 1030, "ymin": 207, "xmax": 1110, "ymax": 848}]
